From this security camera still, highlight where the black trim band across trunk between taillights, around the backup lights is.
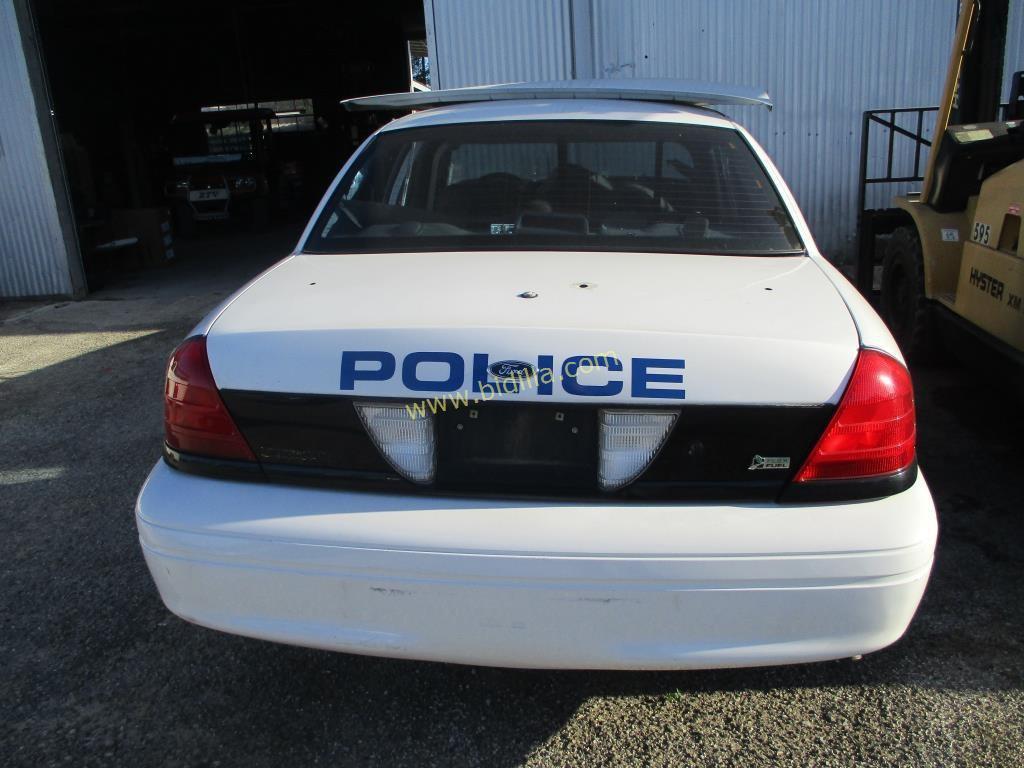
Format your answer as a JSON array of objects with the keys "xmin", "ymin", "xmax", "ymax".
[{"xmin": 193, "ymin": 390, "xmax": 929, "ymax": 503}]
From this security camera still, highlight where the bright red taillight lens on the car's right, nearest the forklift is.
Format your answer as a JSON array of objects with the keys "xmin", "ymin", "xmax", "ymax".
[{"xmin": 796, "ymin": 349, "xmax": 916, "ymax": 482}]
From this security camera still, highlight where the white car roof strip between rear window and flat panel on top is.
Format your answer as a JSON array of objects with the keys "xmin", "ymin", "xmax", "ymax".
[{"xmin": 381, "ymin": 98, "xmax": 736, "ymax": 131}]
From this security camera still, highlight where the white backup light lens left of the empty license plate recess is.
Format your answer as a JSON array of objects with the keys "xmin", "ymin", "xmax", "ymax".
[{"xmin": 355, "ymin": 402, "xmax": 435, "ymax": 482}]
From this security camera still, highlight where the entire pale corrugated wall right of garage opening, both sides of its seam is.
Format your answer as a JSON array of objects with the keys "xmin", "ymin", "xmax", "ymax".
[{"xmin": 427, "ymin": 0, "xmax": 1024, "ymax": 260}]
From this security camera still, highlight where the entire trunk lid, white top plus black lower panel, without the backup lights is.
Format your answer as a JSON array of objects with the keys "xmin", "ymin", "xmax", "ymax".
[{"xmin": 199, "ymin": 252, "xmax": 858, "ymax": 501}]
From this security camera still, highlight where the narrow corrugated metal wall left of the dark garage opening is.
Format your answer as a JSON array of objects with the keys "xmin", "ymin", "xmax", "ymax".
[{"xmin": 0, "ymin": 0, "xmax": 72, "ymax": 297}]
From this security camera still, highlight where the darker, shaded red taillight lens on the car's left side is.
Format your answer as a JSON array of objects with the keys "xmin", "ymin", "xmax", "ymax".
[{"xmin": 164, "ymin": 336, "xmax": 256, "ymax": 461}]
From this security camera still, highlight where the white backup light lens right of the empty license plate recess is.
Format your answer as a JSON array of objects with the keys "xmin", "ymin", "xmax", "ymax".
[{"xmin": 598, "ymin": 410, "xmax": 679, "ymax": 490}]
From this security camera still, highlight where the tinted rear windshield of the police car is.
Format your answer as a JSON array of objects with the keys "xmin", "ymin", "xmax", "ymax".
[{"xmin": 305, "ymin": 120, "xmax": 802, "ymax": 254}]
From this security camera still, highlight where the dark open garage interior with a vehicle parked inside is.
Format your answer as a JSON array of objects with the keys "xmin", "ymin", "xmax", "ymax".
[{"xmin": 31, "ymin": 0, "xmax": 428, "ymax": 290}]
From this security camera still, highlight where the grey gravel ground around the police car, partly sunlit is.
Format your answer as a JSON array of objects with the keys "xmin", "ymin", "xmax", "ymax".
[{"xmin": 0, "ymin": 234, "xmax": 1024, "ymax": 766}]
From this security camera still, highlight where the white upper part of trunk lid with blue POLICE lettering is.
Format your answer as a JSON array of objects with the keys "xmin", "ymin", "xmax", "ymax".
[{"xmin": 208, "ymin": 251, "xmax": 858, "ymax": 406}]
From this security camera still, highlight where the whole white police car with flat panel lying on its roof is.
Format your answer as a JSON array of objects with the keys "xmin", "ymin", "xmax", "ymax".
[{"xmin": 136, "ymin": 81, "xmax": 936, "ymax": 669}]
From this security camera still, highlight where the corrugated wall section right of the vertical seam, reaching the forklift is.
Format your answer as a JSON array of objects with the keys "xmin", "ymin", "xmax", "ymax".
[{"xmin": 593, "ymin": 0, "xmax": 956, "ymax": 259}]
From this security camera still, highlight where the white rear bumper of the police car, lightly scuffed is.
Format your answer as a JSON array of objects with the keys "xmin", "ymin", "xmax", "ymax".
[{"xmin": 136, "ymin": 462, "xmax": 936, "ymax": 669}]
